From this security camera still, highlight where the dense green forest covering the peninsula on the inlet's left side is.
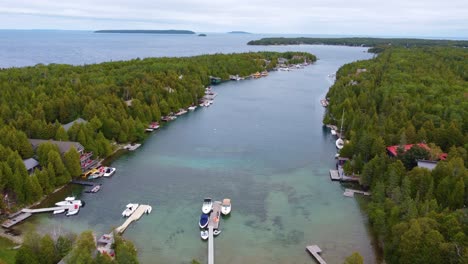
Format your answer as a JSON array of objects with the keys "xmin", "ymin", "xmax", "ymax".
[{"xmin": 0, "ymin": 52, "xmax": 315, "ymax": 212}]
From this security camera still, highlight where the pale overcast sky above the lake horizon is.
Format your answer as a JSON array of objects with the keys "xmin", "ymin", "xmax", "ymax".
[{"xmin": 0, "ymin": 0, "xmax": 468, "ymax": 38}]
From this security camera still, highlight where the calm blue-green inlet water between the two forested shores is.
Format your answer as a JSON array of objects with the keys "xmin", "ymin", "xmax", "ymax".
[{"xmin": 8, "ymin": 32, "xmax": 375, "ymax": 263}]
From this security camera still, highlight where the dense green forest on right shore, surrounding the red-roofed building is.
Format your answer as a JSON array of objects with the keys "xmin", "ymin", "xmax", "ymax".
[{"xmin": 324, "ymin": 47, "xmax": 468, "ymax": 264}]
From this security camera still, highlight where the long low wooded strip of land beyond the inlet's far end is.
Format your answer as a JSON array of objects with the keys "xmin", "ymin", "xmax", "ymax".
[{"xmin": 247, "ymin": 37, "xmax": 468, "ymax": 52}]
